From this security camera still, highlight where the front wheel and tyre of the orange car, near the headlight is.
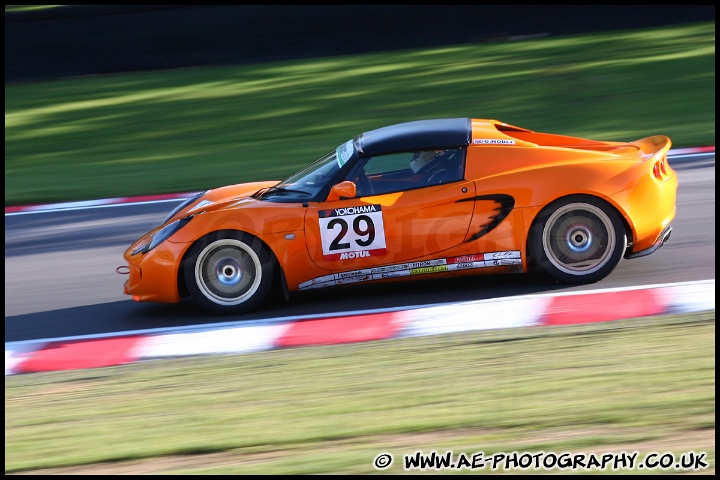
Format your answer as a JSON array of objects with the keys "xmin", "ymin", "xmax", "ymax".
[{"xmin": 183, "ymin": 232, "xmax": 273, "ymax": 315}]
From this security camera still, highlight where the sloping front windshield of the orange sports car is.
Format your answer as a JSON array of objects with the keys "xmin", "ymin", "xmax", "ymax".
[{"xmin": 259, "ymin": 140, "xmax": 355, "ymax": 202}]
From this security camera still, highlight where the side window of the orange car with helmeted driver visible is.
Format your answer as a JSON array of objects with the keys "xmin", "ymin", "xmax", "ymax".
[{"xmin": 347, "ymin": 148, "xmax": 465, "ymax": 197}]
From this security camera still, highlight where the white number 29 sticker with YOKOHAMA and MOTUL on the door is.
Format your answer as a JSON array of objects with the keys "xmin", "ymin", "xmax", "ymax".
[{"xmin": 318, "ymin": 205, "xmax": 385, "ymax": 261}]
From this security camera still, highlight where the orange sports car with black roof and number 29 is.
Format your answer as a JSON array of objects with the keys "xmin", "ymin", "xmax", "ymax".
[{"xmin": 118, "ymin": 118, "xmax": 678, "ymax": 314}]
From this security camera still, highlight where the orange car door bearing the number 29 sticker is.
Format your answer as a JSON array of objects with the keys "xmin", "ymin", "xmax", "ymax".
[{"xmin": 305, "ymin": 180, "xmax": 475, "ymax": 272}]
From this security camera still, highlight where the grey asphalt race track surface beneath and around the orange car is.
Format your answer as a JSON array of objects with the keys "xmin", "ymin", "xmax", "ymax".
[{"xmin": 5, "ymin": 149, "xmax": 715, "ymax": 342}]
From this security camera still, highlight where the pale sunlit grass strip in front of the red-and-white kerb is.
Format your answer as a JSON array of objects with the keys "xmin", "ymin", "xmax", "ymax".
[{"xmin": 5, "ymin": 311, "xmax": 715, "ymax": 474}]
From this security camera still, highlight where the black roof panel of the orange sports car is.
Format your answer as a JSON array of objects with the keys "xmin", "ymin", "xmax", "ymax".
[{"xmin": 355, "ymin": 118, "xmax": 472, "ymax": 155}]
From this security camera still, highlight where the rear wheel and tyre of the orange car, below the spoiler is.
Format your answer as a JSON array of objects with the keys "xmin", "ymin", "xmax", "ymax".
[{"xmin": 528, "ymin": 196, "xmax": 627, "ymax": 284}]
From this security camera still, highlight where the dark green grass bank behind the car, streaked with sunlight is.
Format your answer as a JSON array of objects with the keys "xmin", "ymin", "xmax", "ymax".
[{"xmin": 5, "ymin": 22, "xmax": 715, "ymax": 206}]
